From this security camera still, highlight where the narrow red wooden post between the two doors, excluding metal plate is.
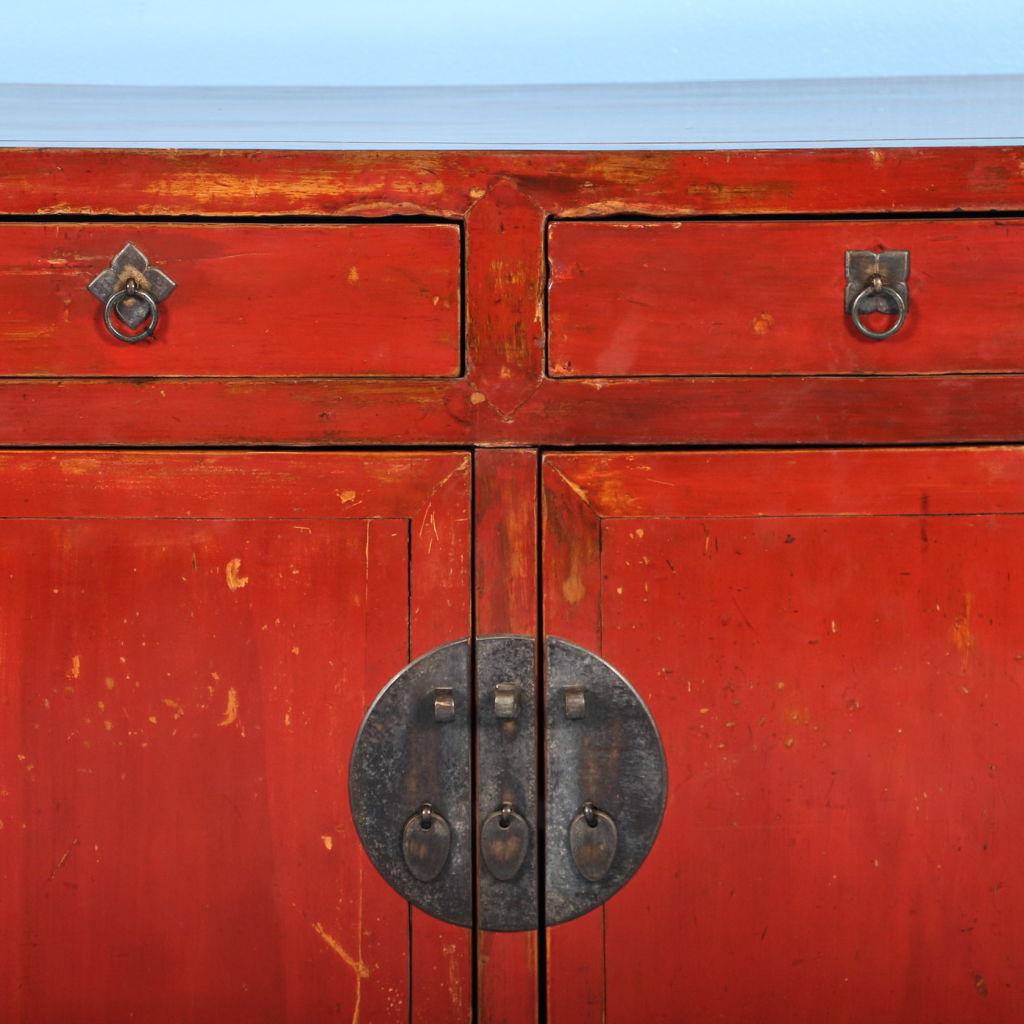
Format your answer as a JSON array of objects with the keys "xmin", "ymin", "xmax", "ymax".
[{"xmin": 474, "ymin": 449, "xmax": 540, "ymax": 1024}]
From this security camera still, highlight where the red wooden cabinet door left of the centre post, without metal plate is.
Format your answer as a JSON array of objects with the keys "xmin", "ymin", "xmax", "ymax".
[{"xmin": 0, "ymin": 452, "xmax": 472, "ymax": 1024}]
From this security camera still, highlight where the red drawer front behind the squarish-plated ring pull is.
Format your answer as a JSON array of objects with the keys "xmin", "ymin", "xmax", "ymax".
[{"xmin": 548, "ymin": 219, "xmax": 1024, "ymax": 377}]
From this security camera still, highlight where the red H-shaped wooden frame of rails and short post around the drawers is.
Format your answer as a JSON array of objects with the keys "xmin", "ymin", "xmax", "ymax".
[{"xmin": 0, "ymin": 147, "xmax": 1024, "ymax": 445}]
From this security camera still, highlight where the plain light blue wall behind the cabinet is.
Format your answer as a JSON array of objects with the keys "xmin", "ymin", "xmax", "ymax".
[{"xmin": 6, "ymin": 0, "xmax": 1024, "ymax": 85}]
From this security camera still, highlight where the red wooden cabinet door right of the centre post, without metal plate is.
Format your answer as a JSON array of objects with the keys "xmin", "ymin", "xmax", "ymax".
[{"xmin": 543, "ymin": 449, "xmax": 1024, "ymax": 1024}]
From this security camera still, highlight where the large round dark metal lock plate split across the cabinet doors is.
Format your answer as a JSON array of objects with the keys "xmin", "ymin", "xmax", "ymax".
[{"xmin": 349, "ymin": 636, "xmax": 667, "ymax": 931}]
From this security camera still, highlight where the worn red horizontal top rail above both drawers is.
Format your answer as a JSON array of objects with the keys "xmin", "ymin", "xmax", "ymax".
[{"xmin": 0, "ymin": 146, "xmax": 1024, "ymax": 217}]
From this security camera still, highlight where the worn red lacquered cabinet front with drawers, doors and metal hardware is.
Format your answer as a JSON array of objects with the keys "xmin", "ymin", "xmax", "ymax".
[{"xmin": 0, "ymin": 147, "xmax": 1024, "ymax": 1024}]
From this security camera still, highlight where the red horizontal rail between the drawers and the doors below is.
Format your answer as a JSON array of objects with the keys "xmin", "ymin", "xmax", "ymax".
[{"xmin": 6, "ymin": 374, "xmax": 1024, "ymax": 446}]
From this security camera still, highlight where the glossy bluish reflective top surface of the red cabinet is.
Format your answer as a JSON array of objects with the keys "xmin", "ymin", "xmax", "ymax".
[{"xmin": 0, "ymin": 75, "xmax": 1024, "ymax": 151}]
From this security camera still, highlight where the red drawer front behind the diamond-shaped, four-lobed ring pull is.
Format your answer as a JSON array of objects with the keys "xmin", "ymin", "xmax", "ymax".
[{"xmin": 0, "ymin": 221, "xmax": 462, "ymax": 377}]
